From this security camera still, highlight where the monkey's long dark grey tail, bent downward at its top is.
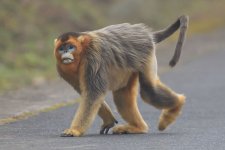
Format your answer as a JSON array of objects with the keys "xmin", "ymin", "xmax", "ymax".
[{"xmin": 153, "ymin": 15, "xmax": 189, "ymax": 67}]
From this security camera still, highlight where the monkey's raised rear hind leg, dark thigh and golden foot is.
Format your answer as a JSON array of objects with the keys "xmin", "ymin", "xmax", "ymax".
[{"xmin": 139, "ymin": 73, "xmax": 185, "ymax": 131}]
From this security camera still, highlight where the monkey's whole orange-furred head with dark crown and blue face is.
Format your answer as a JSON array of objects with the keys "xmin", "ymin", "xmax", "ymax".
[{"xmin": 54, "ymin": 32, "xmax": 90, "ymax": 70}]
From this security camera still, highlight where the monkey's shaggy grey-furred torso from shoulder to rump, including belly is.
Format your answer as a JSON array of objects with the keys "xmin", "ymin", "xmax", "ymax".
[{"xmin": 84, "ymin": 23, "xmax": 157, "ymax": 97}]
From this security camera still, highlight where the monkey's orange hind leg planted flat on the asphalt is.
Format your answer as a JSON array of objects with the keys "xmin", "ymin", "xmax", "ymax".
[{"xmin": 113, "ymin": 74, "xmax": 148, "ymax": 134}]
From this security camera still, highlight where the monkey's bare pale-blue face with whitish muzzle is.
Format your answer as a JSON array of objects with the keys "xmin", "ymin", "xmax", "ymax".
[{"xmin": 58, "ymin": 43, "xmax": 76, "ymax": 64}]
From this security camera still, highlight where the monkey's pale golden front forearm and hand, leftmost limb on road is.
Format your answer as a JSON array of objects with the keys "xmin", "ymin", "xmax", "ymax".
[{"xmin": 61, "ymin": 96, "xmax": 104, "ymax": 137}]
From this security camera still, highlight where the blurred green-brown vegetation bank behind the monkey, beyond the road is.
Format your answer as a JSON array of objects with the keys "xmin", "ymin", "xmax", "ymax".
[{"xmin": 0, "ymin": 0, "xmax": 225, "ymax": 91}]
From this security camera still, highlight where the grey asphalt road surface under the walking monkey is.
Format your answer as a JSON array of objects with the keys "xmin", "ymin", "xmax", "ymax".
[{"xmin": 0, "ymin": 30, "xmax": 225, "ymax": 150}]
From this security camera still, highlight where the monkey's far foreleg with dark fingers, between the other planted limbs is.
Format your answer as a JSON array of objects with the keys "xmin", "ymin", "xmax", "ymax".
[{"xmin": 98, "ymin": 102, "xmax": 118, "ymax": 134}]
